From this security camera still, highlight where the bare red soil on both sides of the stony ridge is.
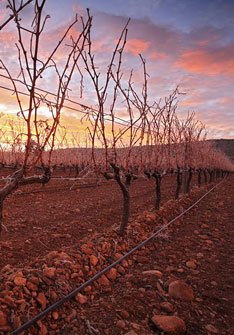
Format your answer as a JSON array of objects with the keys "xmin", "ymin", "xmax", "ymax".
[{"xmin": 0, "ymin": 175, "xmax": 234, "ymax": 335}]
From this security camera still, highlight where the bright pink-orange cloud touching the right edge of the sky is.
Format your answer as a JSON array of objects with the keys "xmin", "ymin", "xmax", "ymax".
[{"xmin": 175, "ymin": 49, "xmax": 234, "ymax": 75}]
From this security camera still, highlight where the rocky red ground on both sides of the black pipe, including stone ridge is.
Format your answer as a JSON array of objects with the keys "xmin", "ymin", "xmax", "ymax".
[{"xmin": 0, "ymin": 176, "xmax": 234, "ymax": 335}]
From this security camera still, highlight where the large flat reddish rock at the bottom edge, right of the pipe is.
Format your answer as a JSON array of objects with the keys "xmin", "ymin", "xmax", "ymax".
[{"xmin": 151, "ymin": 315, "xmax": 186, "ymax": 335}]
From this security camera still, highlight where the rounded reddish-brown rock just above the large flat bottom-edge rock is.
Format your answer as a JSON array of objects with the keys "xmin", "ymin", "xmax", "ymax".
[{"xmin": 168, "ymin": 280, "xmax": 194, "ymax": 301}]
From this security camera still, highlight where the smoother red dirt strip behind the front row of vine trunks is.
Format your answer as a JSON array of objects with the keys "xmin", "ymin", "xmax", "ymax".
[{"xmin": 0, "ymin": 176, "xmax": 175, "ymax": 268}]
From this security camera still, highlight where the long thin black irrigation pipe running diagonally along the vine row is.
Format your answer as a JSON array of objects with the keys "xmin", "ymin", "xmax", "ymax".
[{"xmin": 10, "ymin": 178, "xmax": 226, "ymax": 335}]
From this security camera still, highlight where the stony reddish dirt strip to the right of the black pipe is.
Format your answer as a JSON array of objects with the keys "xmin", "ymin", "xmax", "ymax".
[{"xmin": 61, "ymin": 176, "xmax": 234, "ymax": 335}]
